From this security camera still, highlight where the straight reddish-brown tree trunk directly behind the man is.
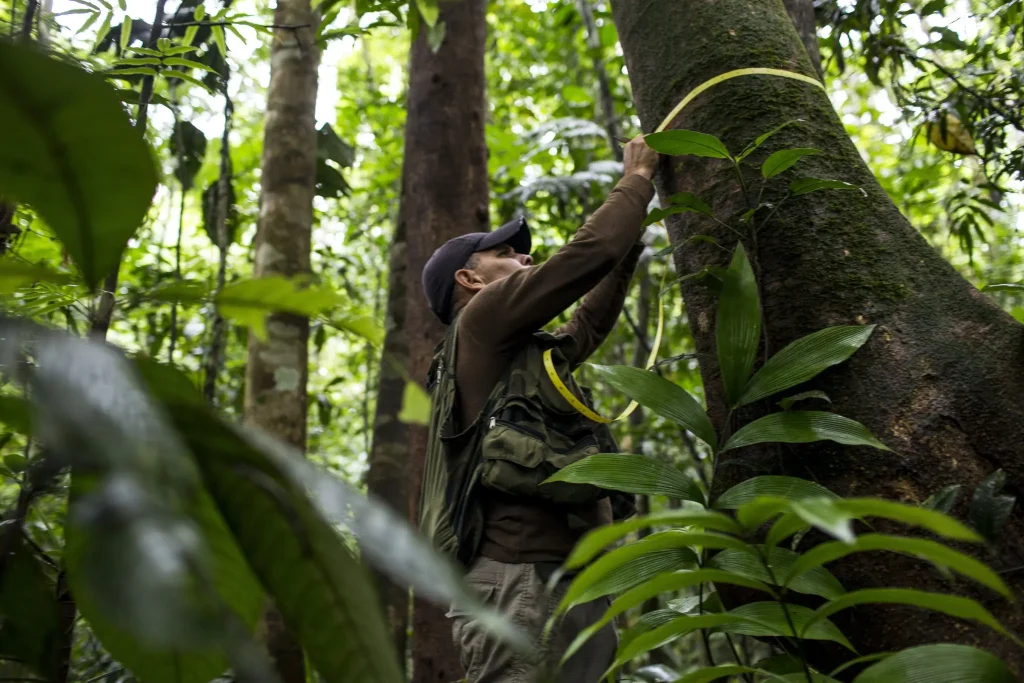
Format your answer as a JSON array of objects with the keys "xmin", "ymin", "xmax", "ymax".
[{"xmin": 367, "ymin": 0, "xmax": 489, "ymax": 683}]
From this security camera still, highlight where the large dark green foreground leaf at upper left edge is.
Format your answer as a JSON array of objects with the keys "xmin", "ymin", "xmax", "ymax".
[{"xmin": 0, "ymin": 43, "xmax": 157, "ymax": 285}]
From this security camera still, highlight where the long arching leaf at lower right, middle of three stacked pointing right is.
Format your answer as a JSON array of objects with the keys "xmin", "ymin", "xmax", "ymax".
[{"xmin": 783, "ymin": 533, "xmax": 1012, "ymax": 597}]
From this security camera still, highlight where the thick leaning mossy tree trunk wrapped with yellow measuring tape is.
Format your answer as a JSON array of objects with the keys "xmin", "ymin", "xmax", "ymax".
[{"xmin": 612, "ymin": 0, "xmax": 1024, "ymax": 673}]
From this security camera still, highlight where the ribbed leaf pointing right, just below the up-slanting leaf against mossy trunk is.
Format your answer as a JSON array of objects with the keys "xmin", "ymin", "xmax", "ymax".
[{"xmin": 722, "ymin": 411, "xmax": 889, "ymax": 451}]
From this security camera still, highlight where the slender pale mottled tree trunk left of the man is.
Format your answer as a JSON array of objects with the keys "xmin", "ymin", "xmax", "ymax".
[{"xmin": 245, "ymin": 0, "xmax": 319, "ymax": 683}]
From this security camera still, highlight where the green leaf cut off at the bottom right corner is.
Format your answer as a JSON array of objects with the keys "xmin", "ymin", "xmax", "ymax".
[{"xmin": 854, "ymin": 643, "xmax": 1017, "ymax": 683}]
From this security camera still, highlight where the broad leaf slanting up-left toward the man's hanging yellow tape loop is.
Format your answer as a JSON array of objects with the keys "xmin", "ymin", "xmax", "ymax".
[{"xmin": 590, "ymin": 366, "xmax": 717, "ymax": 449}]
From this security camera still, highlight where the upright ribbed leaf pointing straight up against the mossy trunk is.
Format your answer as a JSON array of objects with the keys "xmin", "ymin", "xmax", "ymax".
[{"xmin": 715, "ymin": 244, "xmax": 761, "ymax": 405}]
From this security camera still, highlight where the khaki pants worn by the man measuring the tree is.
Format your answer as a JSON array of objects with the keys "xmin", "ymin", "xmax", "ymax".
[{"xmin": 447, "ymin": 557, "xmax": 618, "ymax": 683}]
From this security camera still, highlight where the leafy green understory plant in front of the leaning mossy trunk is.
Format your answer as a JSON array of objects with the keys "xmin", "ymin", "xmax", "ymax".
[{"xmin": 549, "ymin": 122, "xmax": 1020, "ymax": 683}]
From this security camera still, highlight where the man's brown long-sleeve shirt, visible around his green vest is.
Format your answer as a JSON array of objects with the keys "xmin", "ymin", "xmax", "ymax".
[{"xmin": 456, "ymin": 175, "xmax": 654, "ymax": 562}]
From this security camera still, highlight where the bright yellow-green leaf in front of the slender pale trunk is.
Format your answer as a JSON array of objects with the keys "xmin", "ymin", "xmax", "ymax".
[{"xmin": 217, "ymin": 275, "xmax": 341, "ymax": 341}]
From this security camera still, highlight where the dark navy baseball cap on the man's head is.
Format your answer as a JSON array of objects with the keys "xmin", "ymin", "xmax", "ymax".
[{"xmin": 423, "ymin": 218, "xmax": 530, "ymax": 325}]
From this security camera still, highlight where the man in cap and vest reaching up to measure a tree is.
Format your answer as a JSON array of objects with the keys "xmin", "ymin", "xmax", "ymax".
[{"xmin": 421, "ymin": 136, "xmax": 657, "ymax": 683}]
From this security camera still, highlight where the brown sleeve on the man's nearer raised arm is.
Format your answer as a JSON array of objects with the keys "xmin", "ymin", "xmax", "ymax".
[{"xmin": 461, "ymin": 175, "xmax": 654, "ymax": 353}]
